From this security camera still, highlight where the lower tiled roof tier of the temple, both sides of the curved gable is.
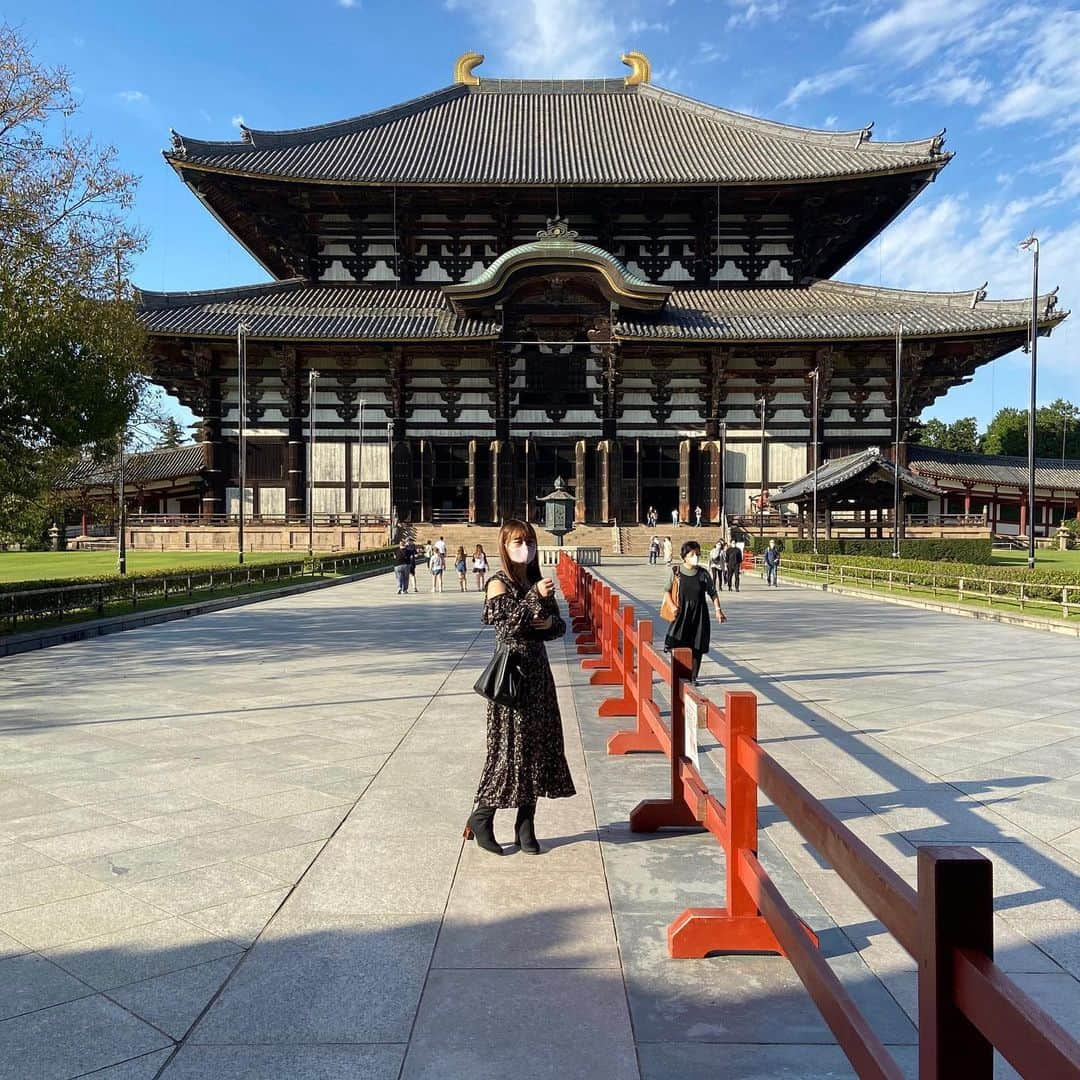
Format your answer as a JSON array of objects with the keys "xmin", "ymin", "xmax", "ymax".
[{"xmin": 139, "ymin": 279, "xmax": 1067, "ymax": 341}]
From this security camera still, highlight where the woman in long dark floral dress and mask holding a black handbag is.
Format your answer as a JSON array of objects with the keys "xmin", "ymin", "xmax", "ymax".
[{"xmin": 464, "ymin": 521, "xmax": 576, "ymax": 855}]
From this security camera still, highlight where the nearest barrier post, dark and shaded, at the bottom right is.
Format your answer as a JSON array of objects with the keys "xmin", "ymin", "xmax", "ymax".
[{"xmin": 918, "ymin": 847, "xmax": 994, "ymax": 1080}]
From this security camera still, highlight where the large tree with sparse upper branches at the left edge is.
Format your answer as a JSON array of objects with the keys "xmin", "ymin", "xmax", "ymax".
[{"xmin": 0, "ymin": 24, "xmax": 145, "ymax": 544}]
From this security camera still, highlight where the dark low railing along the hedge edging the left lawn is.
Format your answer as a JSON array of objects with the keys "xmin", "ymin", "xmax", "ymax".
[{"xmin": 0, "ymin": 551, "xmax": 392, "ymax": 634}]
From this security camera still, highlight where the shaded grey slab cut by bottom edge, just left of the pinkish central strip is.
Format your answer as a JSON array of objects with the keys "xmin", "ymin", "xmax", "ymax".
[{"xmin": 163, "ymin": 1042, "xmax": 405, "ymax": 1080}]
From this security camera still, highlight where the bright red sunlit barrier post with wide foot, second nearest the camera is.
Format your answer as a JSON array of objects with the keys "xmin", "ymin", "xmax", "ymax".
[{"xmin": 667, "ymin": 690, "xmax": 784, "ymax": 959}]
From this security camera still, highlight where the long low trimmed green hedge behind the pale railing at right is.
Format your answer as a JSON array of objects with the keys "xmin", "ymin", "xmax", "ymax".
[{"xmin": 784, "ymin": 545, "xmax": 1080, "ymax": 603}]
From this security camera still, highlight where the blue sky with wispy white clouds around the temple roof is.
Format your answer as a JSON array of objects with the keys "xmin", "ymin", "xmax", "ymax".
[{"xmin": 10, "ymin": 0, "xmax": 1080, "ymax": 423}]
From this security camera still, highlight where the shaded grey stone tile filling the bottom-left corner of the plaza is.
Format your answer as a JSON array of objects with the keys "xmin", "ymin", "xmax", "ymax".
[{"xmin": 0, "ymin": 995, "xmax": 171, "ymax": 1080}]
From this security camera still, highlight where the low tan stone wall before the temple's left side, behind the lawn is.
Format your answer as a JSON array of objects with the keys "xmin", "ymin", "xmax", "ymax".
[{"xmin": 127, "ymin": 522, "xmax": 389, "ymax": 552}]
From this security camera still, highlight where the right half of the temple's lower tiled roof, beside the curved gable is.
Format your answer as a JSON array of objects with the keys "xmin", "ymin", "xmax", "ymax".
[{"xmin": 617, "ymin": 281, "xmax": 1067, "ymax": 341}]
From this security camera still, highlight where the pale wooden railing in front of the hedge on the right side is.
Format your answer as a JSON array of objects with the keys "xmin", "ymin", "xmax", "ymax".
[{"xmin": 783, "ymin": 556, "xmax": 1080, "ymax": 619}]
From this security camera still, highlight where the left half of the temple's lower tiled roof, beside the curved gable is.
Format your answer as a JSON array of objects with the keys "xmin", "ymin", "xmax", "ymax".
[{"xmin": 139, "ymin": 278, "xmax": 499, "ymax": 341}]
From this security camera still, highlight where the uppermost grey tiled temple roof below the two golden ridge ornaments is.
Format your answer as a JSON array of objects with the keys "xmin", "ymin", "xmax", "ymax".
[{"xmin": 166, "ymin": 79, "xmax": 950, "ymax": 185}]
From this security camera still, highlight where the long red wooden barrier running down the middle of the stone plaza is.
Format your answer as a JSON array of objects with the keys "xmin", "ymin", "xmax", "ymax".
[{"xmin": 557, "ymin": 555, "xmax": 1080, "ymax": 1080}]
